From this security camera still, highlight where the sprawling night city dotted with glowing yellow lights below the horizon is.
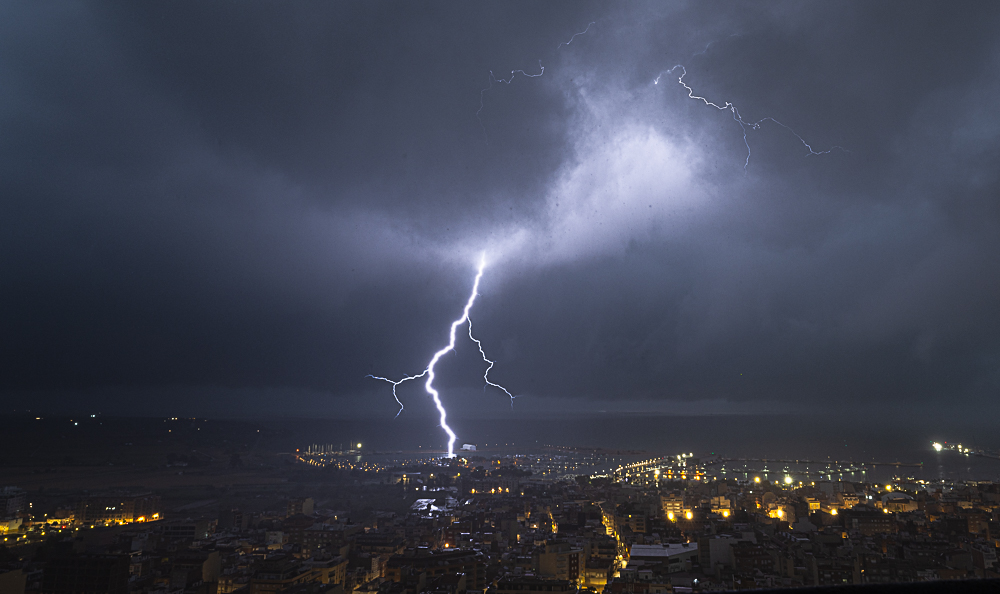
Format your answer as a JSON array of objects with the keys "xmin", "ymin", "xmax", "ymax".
[{"xmin": 0, "ymin": 418, "xmax": 1000, "ymax": 594}]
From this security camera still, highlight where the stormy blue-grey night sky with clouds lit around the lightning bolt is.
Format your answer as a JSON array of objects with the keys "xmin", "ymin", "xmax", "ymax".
[{"xmin": 0, "ymin": 1, "xmax": 1000, "ymax": 418}]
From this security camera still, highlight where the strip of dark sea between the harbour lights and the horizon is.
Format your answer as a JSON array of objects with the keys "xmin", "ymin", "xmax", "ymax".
[{"xmin": 266, "ymin": 414, "xmax": 1000, "ymax": 480}]
